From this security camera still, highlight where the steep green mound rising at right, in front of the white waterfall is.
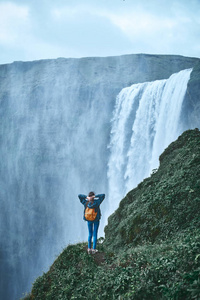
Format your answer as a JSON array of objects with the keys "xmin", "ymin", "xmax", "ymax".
[{"xmin": 105, "ymin": 129, "xmax": 200, "ymax": 251}]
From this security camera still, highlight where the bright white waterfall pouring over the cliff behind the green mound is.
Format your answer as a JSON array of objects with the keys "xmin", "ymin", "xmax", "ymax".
[{"xmin": 107, "ymin": 69, "xmax": 192, "ymax": 214}]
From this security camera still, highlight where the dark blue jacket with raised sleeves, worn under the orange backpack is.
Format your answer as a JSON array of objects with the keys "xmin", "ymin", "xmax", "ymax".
[{"xmin": 78, "ymin": 194, "xmax": 105, "ymax": 222}]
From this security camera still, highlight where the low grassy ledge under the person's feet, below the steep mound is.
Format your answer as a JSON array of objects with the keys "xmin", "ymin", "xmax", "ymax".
[{"xmin": 26, "ymin": 230, "xmax": 200, "ymax": 300}]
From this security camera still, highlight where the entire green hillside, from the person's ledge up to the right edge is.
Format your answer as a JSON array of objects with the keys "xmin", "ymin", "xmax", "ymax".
[{"xmin": 26, "ymin": 129, "xmax": 200, "ymax": 300}]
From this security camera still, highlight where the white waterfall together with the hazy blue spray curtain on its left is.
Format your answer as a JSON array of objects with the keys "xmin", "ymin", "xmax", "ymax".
[{"xmin": 0, "ymin": 60, "xmax": 195, "ymax": 300}]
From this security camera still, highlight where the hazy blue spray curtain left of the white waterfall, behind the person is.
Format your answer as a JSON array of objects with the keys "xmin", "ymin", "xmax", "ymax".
[{"xmin": 0, "ymin": 61, "xmax": 112, "ymax": 300}]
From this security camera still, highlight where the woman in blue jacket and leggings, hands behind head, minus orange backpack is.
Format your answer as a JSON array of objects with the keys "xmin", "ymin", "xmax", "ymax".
[{"xmin": 78, "ymin": 192, "xmax": 105, "ymax": 254}]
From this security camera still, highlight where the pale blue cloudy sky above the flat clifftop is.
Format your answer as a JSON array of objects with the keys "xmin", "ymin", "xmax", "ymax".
[{"xmin": 0, "ymin": 0, "xmax": 200, "ymax": 64}]
